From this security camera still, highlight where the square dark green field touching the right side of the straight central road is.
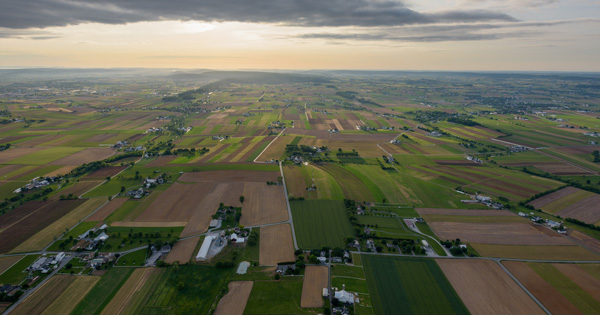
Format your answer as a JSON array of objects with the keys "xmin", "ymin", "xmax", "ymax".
[{"xmin": 290, "ymin": 200, "xmax": 353, "ymax": 249}]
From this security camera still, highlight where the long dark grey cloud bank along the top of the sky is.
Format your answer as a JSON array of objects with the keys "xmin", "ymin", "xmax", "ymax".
[{"xmin": 0, "ymin": 0, "xmax": 516, "ymax": 29}]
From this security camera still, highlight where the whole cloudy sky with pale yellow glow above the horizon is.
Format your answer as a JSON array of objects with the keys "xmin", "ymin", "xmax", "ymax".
[{"xmin": 0, "ymin": 0, "xmax": 600, "ymax": 71}]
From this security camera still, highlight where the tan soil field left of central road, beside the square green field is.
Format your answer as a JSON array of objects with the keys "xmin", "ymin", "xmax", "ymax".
[{"xmin": 240, "ymin": 183, "xmax": 289, "ymax": 226}]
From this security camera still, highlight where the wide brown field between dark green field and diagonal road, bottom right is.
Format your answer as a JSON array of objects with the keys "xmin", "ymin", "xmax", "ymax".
[{"xmin": 436, "ymin": 259, "xmax": 545, "ymax": 314}]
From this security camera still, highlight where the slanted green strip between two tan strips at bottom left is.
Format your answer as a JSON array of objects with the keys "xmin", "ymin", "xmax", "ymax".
[{"xmin": 71, "ymin": 268, "xmax": 133, "ymax": 315}]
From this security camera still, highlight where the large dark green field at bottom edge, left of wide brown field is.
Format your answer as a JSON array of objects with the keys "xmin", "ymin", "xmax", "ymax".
[{"xmin": 361, "ymin": 255, "xmax": 469, "ymax": 314}]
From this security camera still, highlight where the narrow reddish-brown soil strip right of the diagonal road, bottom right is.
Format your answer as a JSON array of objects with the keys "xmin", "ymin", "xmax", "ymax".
[{"xmin": 502, "ymin": 261, "xmax": 581, "ymax": 314}]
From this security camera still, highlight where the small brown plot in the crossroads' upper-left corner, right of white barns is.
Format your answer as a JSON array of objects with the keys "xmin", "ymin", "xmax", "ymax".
[{"xmin": 259, "ymin": 224, "xmax": 296, "ymax": 266}]
